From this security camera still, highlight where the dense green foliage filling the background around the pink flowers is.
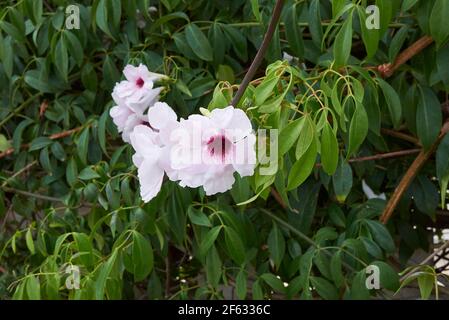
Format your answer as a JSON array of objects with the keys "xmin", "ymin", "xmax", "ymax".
[{"xmin": 0, "ymin": 0, "xmax": 449, "ymax": 299}]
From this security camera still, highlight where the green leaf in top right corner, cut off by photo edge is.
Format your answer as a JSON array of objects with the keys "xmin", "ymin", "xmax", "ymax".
[{"xmin": 429, "ymin": 0, "xmax": 449, "ymax": 47}]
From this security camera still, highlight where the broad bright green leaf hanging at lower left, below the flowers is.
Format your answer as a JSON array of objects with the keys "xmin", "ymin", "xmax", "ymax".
[{"xmin": 132, "ymin": 231, "xmax": 153, "ymax": 281}]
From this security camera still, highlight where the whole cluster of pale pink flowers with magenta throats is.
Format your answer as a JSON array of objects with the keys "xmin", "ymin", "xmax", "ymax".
[{"xmin": 110, "ymin": 65, "xmax": 256, "ymax": 202}]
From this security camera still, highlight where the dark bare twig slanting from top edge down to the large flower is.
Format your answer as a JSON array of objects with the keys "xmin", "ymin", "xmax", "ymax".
[{"xmin": 231, "ymin": 0, "xmax": 284, "ymax": 107}]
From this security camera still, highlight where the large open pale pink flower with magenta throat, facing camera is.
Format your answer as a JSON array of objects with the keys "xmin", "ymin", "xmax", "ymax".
[{"xmin": 169, "ymin": 106, "xmax": 256, "ymax": 195}]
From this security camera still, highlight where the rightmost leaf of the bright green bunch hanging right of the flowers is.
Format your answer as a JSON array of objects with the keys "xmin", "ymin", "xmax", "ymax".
[{"xmin": 346, "ymin": 101, "xmax": 368, "ymax": 158}]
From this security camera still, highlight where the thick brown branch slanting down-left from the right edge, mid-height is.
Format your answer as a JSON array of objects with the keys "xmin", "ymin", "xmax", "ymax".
[{"xmin": 379, "ymin": 122, "xmax": 449, "ymax": 224}]
